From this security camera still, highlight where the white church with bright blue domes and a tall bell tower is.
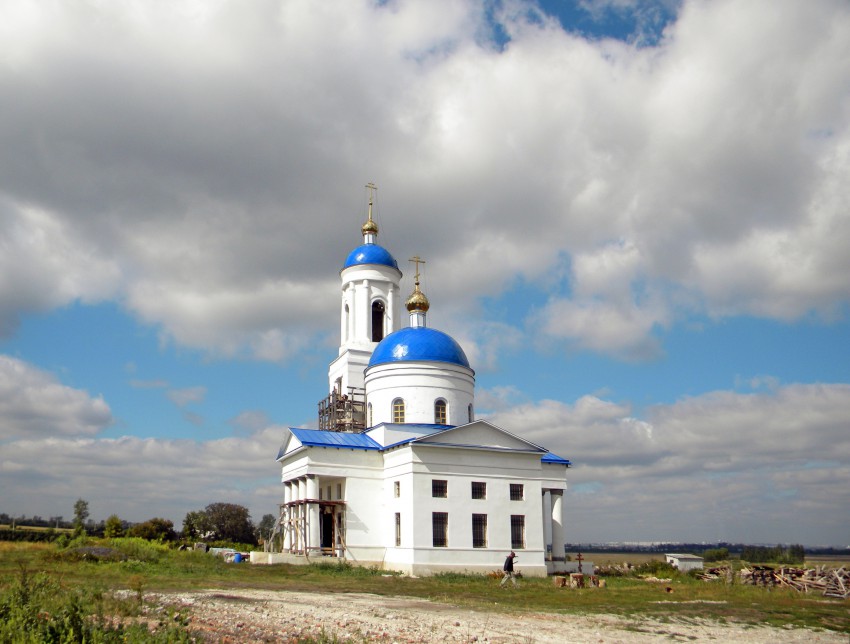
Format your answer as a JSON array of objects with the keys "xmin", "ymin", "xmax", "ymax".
[{"xmin": 264, "ymin": 189, "xmax": 570, "ymax": 576}]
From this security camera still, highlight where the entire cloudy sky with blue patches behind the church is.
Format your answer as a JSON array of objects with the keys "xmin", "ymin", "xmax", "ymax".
[{"xmin": 0, "ymin": 0, "xmax": 850, "ymax": 545}]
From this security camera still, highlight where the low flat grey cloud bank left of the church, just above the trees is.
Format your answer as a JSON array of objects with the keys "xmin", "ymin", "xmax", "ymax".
[{"xmin": 0, "ymin": 428, "xmax": 283, "ymax": 529}]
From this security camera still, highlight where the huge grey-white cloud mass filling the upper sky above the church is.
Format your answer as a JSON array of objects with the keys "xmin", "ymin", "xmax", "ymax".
[{"xmin": 0, "ymin": 0, "xmax": 850, "ymax": 365}]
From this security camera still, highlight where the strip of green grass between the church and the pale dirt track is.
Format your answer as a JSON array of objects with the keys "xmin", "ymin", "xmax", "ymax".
[{"xmin": 0, "ymin": 540, "xmax": 850, "ymax": 641}]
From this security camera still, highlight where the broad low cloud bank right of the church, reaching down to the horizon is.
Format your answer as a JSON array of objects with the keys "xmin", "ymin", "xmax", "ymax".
[{"xmin": 491, "ymin": 384, "xmax": 850, "ymax": 544}]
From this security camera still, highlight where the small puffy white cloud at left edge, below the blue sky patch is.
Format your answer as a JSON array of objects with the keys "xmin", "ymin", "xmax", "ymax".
[{"xmin": 0, "ymin": 355, "xmax": 114, "ymax": 440}]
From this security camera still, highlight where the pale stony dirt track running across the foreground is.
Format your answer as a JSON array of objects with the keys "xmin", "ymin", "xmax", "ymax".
[{"xmin": 151, "ymin": 588, "xmax": 848, "ymax": 644}]
